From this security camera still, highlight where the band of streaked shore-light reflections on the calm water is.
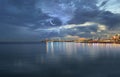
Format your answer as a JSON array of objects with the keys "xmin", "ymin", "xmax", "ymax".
[{"xmin": 46, "ymin": 42, "xmax": 120, "ymax": 58}]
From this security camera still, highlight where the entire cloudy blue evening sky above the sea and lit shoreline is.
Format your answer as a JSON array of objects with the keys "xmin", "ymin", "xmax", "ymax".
[{"xmin": 0, "ymin": 0, "xmax": 120, "ymax": 41}]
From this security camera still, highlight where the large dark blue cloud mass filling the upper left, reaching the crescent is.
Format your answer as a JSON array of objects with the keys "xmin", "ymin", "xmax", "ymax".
[{"xmin": 0, "ymin": 0, "xmax": 61, "ymax": 29}]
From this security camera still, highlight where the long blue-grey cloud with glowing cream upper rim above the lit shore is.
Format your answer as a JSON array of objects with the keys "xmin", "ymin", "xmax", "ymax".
[{"xmin": 35, "ymin": 22, "xmax": 107, "ymax": 37}]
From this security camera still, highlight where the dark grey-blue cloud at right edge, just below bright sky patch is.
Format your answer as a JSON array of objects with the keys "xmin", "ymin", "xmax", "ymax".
[{"xmin": 95, "ymin": 11, "xmax": 120, "ymax": 29}]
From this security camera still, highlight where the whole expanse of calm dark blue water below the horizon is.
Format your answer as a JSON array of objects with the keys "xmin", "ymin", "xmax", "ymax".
[{"xmin": 0, "ymin": 42, "xmax": 120, "ymax": 77}]
